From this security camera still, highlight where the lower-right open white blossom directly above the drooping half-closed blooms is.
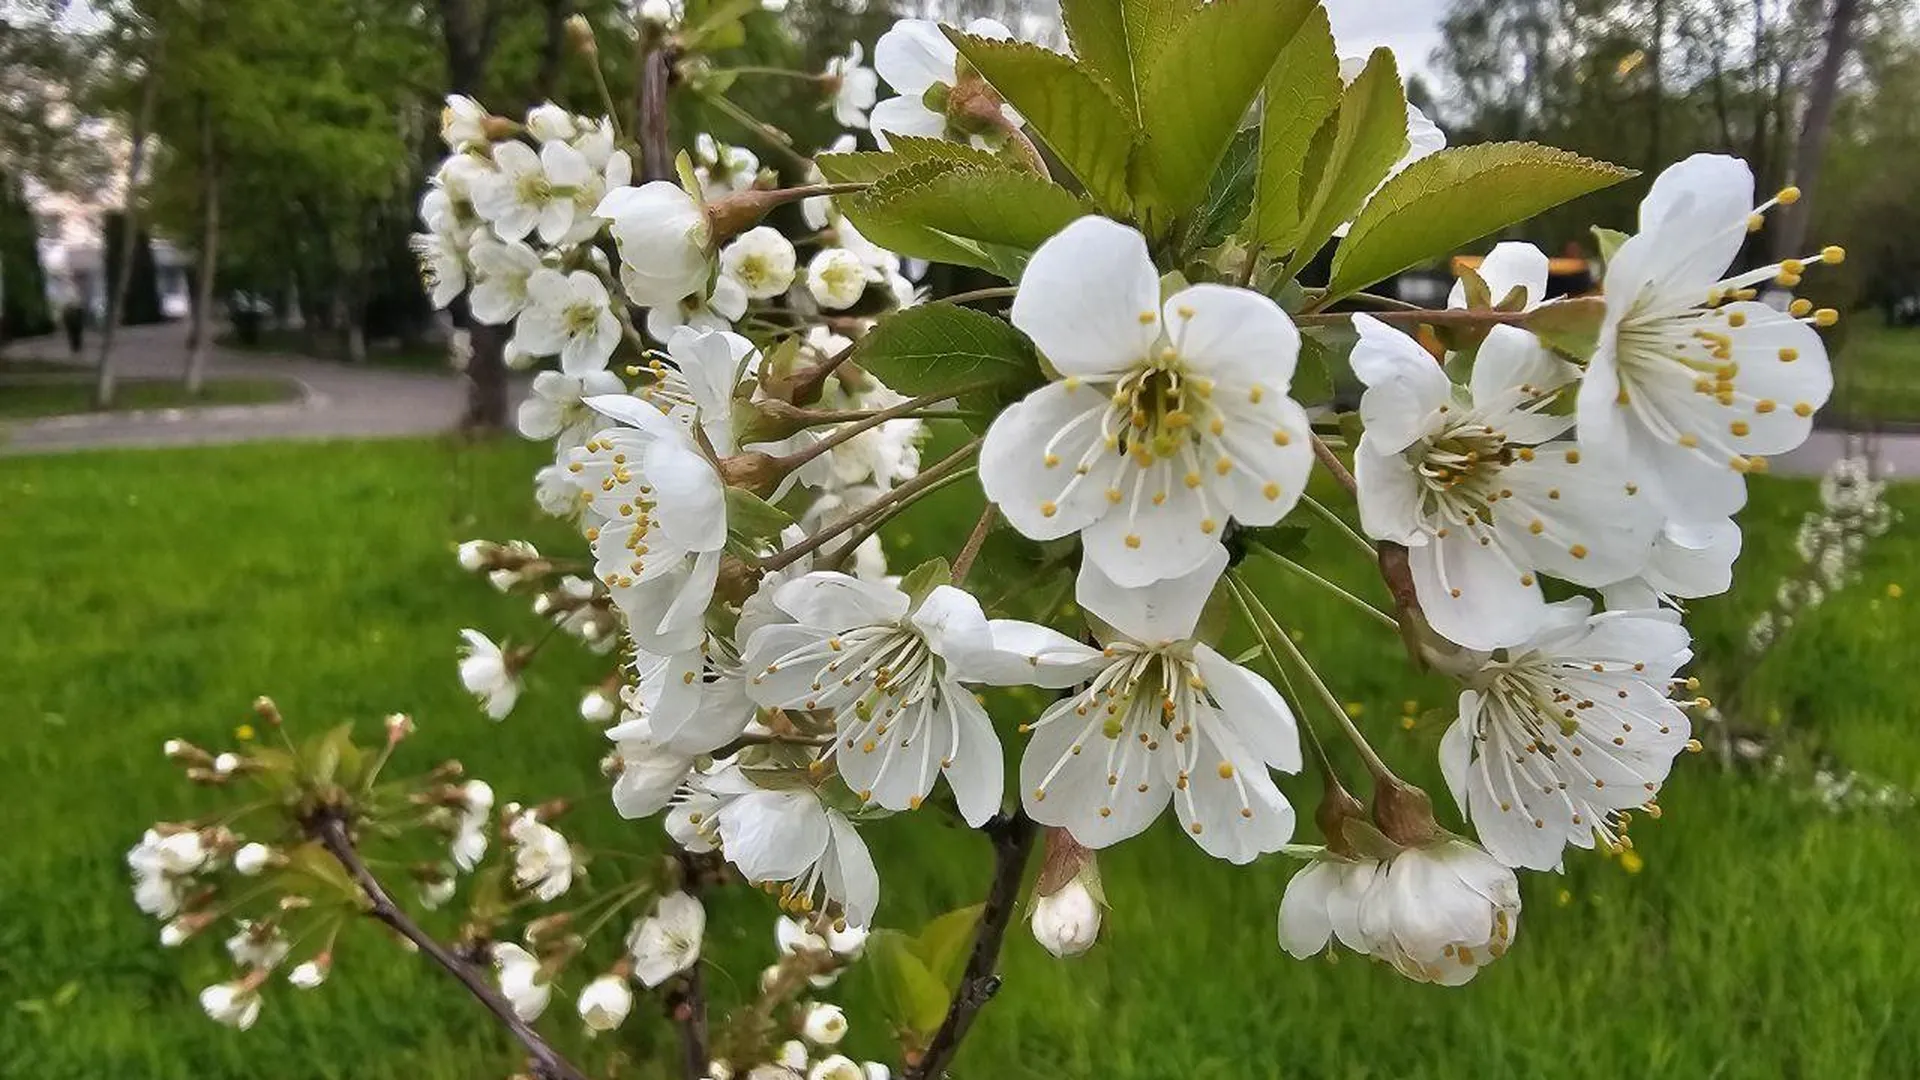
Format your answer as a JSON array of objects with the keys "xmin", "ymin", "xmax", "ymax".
[{"xmin": 1440, "ymin": 598, "xmax": 1693, "ymax": 871}]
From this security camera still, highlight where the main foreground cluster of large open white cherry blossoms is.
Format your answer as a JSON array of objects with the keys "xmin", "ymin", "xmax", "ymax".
[{"xmin": 439, "ymin": 92, "xmax": 1839, "ymax": 984}]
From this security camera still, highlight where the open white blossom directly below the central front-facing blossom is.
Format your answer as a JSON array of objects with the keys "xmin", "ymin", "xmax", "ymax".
[{"xmin": 1020, "ymin": 546, "xmax": 1300, "ymax": 863}]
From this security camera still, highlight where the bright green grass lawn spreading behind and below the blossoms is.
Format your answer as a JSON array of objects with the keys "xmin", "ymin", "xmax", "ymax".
[{"xmin": 0, "ymin": 442, "xmax": 1920, "ymax": 1080}]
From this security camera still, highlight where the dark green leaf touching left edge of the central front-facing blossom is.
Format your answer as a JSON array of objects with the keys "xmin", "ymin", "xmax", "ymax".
[{"xmin": 852, "ymin": 304, "xmax": 1046, "ymax": 417}]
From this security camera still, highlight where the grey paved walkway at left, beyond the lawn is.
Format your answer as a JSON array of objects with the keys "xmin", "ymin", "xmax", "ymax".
[{"xmin": 0, "ymin": 323, "xmax": 522, "ymax": 454}]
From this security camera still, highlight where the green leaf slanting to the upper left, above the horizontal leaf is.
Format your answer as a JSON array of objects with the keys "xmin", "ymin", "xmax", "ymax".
[{"xmin": 941, "ymin": 27, "xmax": 1137, "ymax": 215}]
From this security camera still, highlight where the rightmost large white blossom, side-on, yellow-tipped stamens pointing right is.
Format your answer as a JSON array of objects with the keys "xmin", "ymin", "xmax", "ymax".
[{"xmin": 1578, "ymin": 154, "xmax": 1834, "ymax": 523}]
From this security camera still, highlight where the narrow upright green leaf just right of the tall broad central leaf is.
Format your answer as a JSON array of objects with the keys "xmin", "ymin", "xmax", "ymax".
[{"xmin": 1254, "ymin": 8, "xmax": 1340, "ymax": 246}]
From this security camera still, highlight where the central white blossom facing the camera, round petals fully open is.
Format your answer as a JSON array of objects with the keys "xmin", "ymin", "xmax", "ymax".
[{"xmin": 979, "ymin": 217, "xmax": 1313, "ymax": 586}]
